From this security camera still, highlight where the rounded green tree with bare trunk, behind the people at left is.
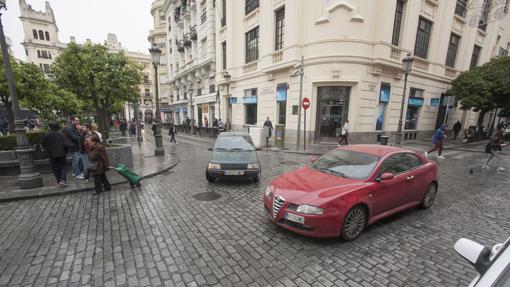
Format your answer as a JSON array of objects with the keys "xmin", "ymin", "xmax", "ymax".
[{"xmin": 52, "ymin": 43, "xmax": 142, "ymax": 139}]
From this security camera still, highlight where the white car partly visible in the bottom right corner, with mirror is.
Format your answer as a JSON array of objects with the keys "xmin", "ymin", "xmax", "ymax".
[{"xmin": 454, "ymin": 238, "xmax": 510, "ymax": 287}]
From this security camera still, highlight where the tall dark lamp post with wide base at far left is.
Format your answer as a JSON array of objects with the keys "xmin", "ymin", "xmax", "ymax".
[{"xmin": 0, "ymin": 0, "xmax": 43, "ymax": 189}]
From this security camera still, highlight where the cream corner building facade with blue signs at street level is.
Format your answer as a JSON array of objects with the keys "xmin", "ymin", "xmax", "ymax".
[{"xmin": 211, "ymin": 0, "xmax": 510, "ymax": 143}]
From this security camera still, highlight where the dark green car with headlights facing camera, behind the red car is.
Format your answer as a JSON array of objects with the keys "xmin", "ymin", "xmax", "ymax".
[{"xmin": 205, "ymin": 132, "xmax": 261, "ymax": 182}]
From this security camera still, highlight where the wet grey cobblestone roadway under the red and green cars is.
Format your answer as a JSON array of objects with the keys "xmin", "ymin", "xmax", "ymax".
[{"xmin": 0, "ymin": 137, "xmax": 510, "ymax": 286}]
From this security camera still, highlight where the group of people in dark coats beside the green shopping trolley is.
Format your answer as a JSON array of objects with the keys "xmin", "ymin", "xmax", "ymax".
[{"xmin": 43, "ymin": 118, "xmax": 111, "ymax": 193}]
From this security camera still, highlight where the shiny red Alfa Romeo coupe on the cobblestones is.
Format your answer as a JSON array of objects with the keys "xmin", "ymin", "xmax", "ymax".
[{"xmin": 264, "ymin": 145, "xmax": 438, "ymax": 241}]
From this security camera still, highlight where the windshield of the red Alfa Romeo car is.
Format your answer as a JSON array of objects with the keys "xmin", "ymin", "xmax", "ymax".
[{"xmin": 311, "ymin": 150, "xmax": 379, "ymax": 179}]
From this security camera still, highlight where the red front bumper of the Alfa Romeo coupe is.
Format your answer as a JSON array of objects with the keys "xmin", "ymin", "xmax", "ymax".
[{"xmin": 264, "ymin": 195, "xmax": 343, "ymax": 237}]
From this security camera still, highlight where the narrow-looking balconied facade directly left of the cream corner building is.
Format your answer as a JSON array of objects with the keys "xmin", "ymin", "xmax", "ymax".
[{"xmin": 152, "ymin": 0, "xmax": 216, "ymax": 127}]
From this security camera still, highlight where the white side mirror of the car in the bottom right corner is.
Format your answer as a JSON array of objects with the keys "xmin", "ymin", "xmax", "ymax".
[{"xmin": 453, "ymin": 238, "xmax": 491, "ymax": 274}]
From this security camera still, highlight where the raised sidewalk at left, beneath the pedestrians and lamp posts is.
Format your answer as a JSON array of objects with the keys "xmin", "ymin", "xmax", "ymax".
[{"xmin": 0, "ymin": 135, "xmax": 180, "ymax": 202}]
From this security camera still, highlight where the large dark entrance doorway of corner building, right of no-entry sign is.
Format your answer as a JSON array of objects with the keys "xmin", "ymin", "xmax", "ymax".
[{"xmin": 315, "ymin": 86, "xmax": 351, "ymax": 142}]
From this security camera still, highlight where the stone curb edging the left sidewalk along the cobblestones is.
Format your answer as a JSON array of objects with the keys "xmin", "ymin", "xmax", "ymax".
[{"xmin": 0, "ymin": 156, "xmax": 181, "ymax": 202}]
